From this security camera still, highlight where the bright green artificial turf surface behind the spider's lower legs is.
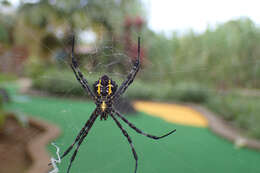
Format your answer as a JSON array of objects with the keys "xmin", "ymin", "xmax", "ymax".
[{"xmin": 5, "ymin": 87, "xmax": 260, "ymax": 173}]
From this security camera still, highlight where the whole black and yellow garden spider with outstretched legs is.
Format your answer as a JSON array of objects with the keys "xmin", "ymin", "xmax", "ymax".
[{"xmin": 61, "ymin": 36, "xmax": 176, "ymax": 173}]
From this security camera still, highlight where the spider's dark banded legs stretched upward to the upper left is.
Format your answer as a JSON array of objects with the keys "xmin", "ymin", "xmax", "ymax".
[{"xmin": 70, "ymin": 35, "xmax": 95, "ymax": 99}]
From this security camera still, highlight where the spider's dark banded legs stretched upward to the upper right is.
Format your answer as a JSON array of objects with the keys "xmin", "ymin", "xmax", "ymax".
[{"xmin": 112, "ymin": 37, "xmax": 140, "ymax": 99}]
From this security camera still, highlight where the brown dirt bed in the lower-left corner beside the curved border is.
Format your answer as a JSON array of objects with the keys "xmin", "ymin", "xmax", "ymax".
[{"xmin": 0, "ymin": 117, "xmax": 40, "ymax": 173}]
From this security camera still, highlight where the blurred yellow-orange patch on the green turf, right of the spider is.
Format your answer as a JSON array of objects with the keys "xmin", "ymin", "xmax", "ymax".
[{"xmin": 134, "ymin": 101, "xmax": 208, "ymax": 127}]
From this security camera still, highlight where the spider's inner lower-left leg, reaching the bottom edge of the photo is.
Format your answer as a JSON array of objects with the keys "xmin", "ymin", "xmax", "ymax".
[{"xmin": 67, "ymin": 111, "xmax": 98, "ymax": 173}]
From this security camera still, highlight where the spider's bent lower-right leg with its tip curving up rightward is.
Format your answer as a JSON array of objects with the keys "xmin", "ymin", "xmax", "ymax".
[{"xmin": 113, "ymin": 109, "xmax": 176, "ymax": 140}]
